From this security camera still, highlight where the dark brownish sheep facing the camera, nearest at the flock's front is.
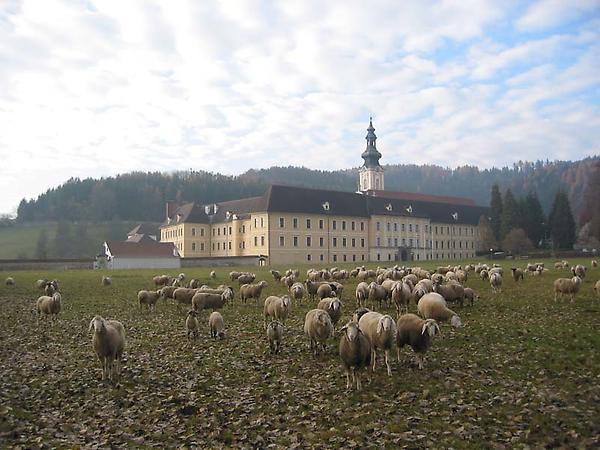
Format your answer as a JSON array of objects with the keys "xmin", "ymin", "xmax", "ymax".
[{"xmin": 339, "ymin": 322, "xmax": 372, "ymax": 391}]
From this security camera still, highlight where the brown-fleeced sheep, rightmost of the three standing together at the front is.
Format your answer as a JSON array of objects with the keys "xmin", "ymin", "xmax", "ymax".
[{"xmin": 396, "ymin": 314, "xmax": 440, "ymax": 370}]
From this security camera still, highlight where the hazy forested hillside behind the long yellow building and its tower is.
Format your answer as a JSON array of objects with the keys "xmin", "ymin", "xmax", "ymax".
[{"xmin": 18, "ymin": 157, "xmax": 600, "ymax": 222}]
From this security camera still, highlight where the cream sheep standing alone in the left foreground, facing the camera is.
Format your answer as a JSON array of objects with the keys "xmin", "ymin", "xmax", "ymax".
[{"xmin": 89, "ymin": 316, "xmax": 126, "ymax": 381}]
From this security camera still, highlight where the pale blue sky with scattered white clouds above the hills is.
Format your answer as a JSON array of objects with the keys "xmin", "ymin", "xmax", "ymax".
[{"xmin": 0, "ymin": 0, "xmax": 600, "ymax": 214}]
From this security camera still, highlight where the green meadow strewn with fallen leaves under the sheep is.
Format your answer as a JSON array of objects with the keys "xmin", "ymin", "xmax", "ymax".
[{"xmin": 0, "ymin": 260, "xmax": 600, "ymax": 448}]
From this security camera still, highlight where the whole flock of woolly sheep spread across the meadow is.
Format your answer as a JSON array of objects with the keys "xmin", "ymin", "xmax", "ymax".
[{"xmin": 5, "ymin": 260, "xmax": 600, "ymax": 390}]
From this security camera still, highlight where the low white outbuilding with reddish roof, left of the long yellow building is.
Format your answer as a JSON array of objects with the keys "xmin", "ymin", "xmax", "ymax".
[{"xmin": 103, "ymin": 236, "xmax": 181, "ymax": 269}]
